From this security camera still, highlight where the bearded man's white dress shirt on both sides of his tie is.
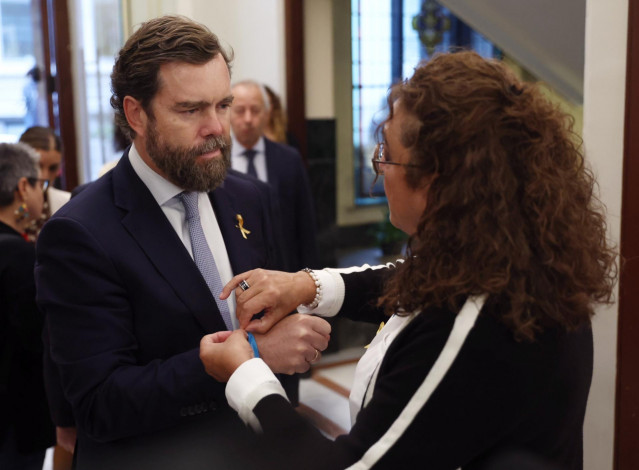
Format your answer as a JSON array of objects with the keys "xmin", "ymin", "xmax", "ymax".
[{"xmin": 129, "ymin": 144, "xmax": 239, "ymax": 329}]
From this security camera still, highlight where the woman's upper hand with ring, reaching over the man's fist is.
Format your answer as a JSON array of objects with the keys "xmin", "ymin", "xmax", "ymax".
[{"xmin": 220, "ymin": 269, "xmax": 315, "ymax": 333}]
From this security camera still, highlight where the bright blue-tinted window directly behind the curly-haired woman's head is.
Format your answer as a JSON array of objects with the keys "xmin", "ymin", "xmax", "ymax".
[{"xmin": 351, "ymin": 0, "xmax": 500, "ymax": 204}]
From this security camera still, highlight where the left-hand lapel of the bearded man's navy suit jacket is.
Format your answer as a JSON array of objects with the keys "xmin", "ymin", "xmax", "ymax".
[{"xmin": 113, "ymin": 155, "xmax": 226, "ymax": 332}]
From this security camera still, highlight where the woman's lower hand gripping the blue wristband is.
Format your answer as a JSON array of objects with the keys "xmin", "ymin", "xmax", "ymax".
[{"xmin": 200, "ymin": 330, "xmax": 253, "ymax": 382}]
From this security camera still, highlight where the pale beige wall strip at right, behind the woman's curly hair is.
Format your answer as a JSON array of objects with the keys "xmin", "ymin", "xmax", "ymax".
[{"xmin": 583, "ymin": 0, "xmax": 628, "ymax": 470}]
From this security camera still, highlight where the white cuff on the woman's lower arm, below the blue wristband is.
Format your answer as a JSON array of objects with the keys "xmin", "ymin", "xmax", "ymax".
[{"xmin": 225, "ymin": 358, "xmax": 288, "ymax": 432}]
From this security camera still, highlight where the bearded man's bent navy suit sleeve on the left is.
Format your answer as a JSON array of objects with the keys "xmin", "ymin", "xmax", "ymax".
[{"xmin": 35, "ymin": 217, "xmax": 224, "ymax": 442}]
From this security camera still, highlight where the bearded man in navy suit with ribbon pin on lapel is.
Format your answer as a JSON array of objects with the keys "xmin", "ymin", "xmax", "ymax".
[{"xmin": 36, "ymin": 16, "xmax": 330, "ymax": 470}]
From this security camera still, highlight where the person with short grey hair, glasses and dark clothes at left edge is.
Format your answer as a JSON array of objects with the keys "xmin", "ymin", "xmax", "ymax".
[{"xmin": 0, "ymin": 144, "xmax": 55, "ymax": 470}]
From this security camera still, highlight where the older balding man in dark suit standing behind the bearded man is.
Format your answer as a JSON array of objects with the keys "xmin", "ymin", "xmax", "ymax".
[{"xmin": 231, "ymin": 80, "xmax": 318, "ymax": 271}]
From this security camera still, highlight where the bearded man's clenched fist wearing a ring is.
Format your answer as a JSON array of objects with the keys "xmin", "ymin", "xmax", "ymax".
[{"xmin": 255, "ymin": 314, "xmax": 331, "ymax": 374}]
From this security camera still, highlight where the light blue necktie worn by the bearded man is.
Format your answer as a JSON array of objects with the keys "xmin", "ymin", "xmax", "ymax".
[{"xmin": 178, "ymin": 192, "xmax": 233, "ymax": 330}]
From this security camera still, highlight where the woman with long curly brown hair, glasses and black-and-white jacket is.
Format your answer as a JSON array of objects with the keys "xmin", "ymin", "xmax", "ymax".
[{"xmin": 200, "ymin": 52, "xmax": 616, "ymax": 469}]
